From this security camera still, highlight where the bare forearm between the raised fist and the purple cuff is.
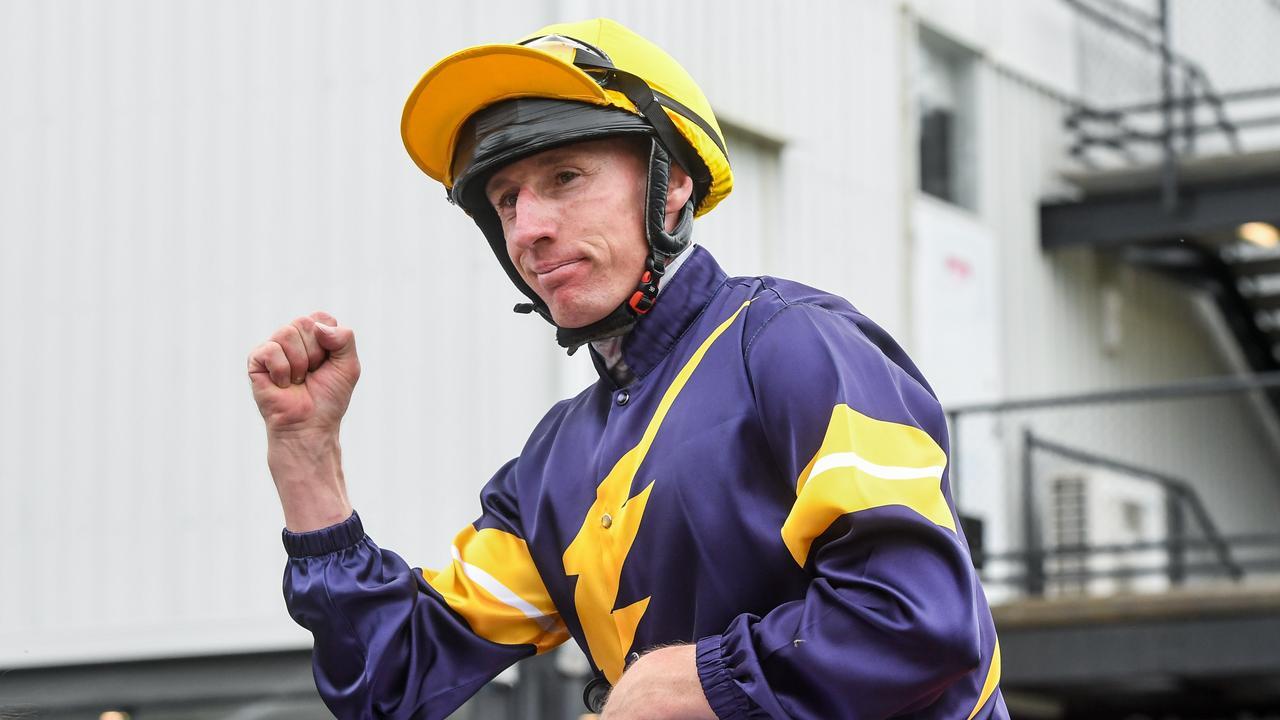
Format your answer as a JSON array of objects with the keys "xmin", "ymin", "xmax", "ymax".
[{"xmin": 266, "ymin": 427, "xmax": 351, "ymax": 533}]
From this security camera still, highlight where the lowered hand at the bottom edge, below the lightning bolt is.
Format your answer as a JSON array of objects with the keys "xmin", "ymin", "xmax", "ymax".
[{"xmin": 600, "ymin": 644, "xmax": 716, "ymax": 720}]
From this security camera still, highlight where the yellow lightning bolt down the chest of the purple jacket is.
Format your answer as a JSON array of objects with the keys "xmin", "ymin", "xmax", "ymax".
[{"xmin": 564, "ymin": 300, "xmax": 751, "ymax": 683}]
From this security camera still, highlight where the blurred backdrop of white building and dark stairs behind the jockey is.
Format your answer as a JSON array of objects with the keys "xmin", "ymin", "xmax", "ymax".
[{"xmin": 0, "ymin": 0, "xmax": 1280, "ymax": 720}]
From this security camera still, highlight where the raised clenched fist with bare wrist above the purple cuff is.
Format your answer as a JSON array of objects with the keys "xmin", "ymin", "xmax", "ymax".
[{"xmin": 248, "ymin": 313, "xmax": 360, "ymax": 532}]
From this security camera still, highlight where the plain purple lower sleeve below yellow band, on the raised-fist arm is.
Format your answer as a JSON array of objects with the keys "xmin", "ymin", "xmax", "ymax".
[{"xmin": 284, "ymin": 514, "xmax": 534, "ymax": 719}]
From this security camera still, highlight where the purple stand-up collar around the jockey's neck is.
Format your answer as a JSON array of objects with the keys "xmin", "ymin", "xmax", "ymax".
[{"xmin": 601, "ymin": 246, "xmax": 728, "ymax": 378}]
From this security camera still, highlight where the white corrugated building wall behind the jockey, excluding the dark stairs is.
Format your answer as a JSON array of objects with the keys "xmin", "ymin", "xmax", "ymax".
[{"xmin": 0, "ymin": 0, "xmax": 1280, "ymax": 719}]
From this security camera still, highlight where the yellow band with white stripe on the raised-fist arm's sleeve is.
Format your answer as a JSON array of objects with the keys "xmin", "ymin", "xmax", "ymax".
[{"xmin": 422, "ymin": 525, "xmax": 568, "ymax": 653}]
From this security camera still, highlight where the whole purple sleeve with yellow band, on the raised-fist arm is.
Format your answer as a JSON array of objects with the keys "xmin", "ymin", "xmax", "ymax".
[{"xmin": 284, "ymin": 450, "xmax": 568, "ymax": 719}]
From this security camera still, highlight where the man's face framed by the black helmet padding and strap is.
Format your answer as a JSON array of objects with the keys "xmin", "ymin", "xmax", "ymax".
[{"xmin": 485, "ymin": 138, "xmax": 649, "ymax": 328}]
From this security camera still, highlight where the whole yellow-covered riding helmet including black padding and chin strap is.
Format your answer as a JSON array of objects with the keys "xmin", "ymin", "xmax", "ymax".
[{"xmin": 401, "ymin": 19, "xmax": 733, "ymax": 354}]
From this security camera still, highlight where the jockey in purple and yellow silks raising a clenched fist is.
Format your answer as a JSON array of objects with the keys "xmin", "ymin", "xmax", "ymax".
[{"xmin": 250, "ymin": 20, "xmax": 1007, "ymax": 720}]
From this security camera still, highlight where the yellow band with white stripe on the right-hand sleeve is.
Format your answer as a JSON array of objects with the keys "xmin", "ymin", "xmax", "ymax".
[{"xmin": 782, "ymin": 404, "xmax": 956, "ymax": 566}]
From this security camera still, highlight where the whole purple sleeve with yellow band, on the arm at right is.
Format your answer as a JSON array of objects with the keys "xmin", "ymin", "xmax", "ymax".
[{"xmin": 698, "ymin": 305, "xmax": 986, "ymax": 720}]
